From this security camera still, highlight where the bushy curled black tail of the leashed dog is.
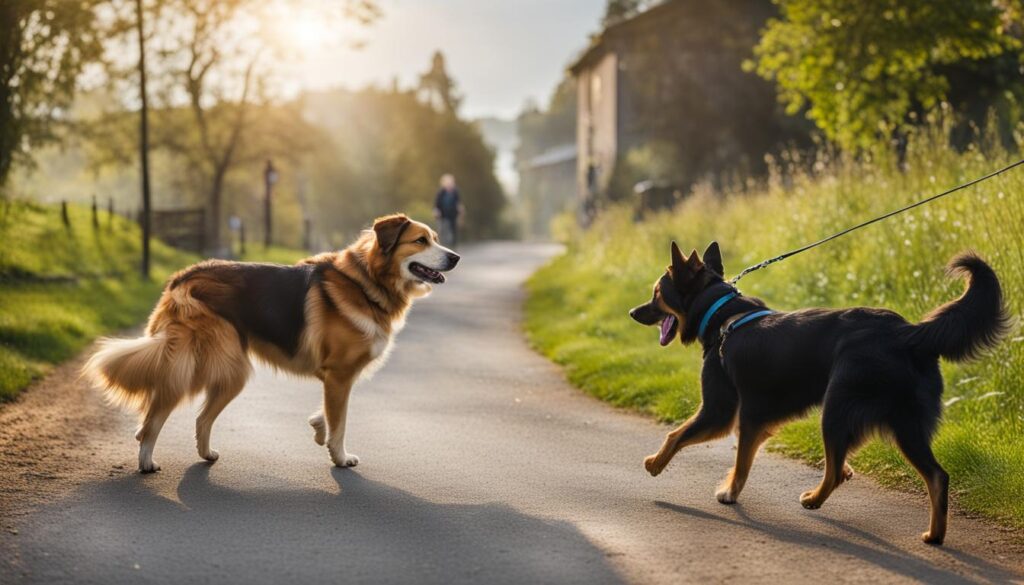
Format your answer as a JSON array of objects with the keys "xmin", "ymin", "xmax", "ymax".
[{"xmin": 905, "ymin": 252, "xmax": 1012, "ymax": 362}]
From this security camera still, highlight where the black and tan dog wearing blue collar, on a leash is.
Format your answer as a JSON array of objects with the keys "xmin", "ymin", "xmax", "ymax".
[{"xmin": 630, "ymin": 243, "xmax": 1010, "ymax": 544}]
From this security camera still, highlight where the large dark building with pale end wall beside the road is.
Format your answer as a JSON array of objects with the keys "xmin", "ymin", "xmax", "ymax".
[{"xmin": 569, "ymin": 0, "xmax": 810, "ymax": 217}]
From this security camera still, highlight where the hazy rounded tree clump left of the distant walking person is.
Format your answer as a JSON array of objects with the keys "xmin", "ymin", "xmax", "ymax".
[{"xmin": 305, "ymin": 82, "xmax": 508, "ymax": 246}]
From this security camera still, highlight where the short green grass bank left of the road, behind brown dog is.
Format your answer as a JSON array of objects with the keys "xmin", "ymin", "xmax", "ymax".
[{"xmin": 0, "ymin": 202, "xmax": 306, "ymax": 402}]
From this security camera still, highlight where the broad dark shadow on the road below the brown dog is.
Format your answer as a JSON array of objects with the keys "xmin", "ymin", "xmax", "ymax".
[{"xmin": 14, "ymin": 463, "xmax": 623, "ymax": 583}]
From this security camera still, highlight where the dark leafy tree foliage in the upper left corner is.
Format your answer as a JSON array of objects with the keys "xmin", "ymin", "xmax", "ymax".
[{"xmin": 0, "ymin": 0, "xmax": 102, "ymax": 190}]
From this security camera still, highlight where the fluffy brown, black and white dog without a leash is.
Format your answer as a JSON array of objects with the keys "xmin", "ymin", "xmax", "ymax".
[{"xmin": 84, "ymin": 214, "xmax": 459, "ymax": 472}]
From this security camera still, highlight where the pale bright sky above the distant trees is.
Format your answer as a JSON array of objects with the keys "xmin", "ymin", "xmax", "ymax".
[{"xmin": 299, "ymin": 0, "xmax": 605, "ymax": 118}]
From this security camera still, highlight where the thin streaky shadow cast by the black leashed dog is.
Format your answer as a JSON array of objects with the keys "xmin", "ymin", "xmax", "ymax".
[{"xmin": 654, "ymin": 501, "xmax": 1020, "ymax": 583}]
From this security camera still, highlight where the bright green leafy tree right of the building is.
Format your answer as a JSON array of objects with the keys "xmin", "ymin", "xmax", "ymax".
[{"xmin": 751, "ymin": 0, "xmax": 1022, "ymax": 149}]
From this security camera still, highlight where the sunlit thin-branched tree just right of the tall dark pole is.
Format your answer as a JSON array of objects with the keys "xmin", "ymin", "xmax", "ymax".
[{"xmin": 93, "ymin": 0, "xmax": 379, "ymax": 250}]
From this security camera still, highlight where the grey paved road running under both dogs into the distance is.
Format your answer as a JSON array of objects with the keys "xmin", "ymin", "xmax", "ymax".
[{"xmin": 0, "ymin": 244, "xmax": 1024, "ymax": 584}]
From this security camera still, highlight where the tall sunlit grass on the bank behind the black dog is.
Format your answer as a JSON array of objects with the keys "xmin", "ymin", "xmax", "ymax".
[{"xmin": 525, "ymin": 137, "xmax": 1024, "ymax": 528}]
